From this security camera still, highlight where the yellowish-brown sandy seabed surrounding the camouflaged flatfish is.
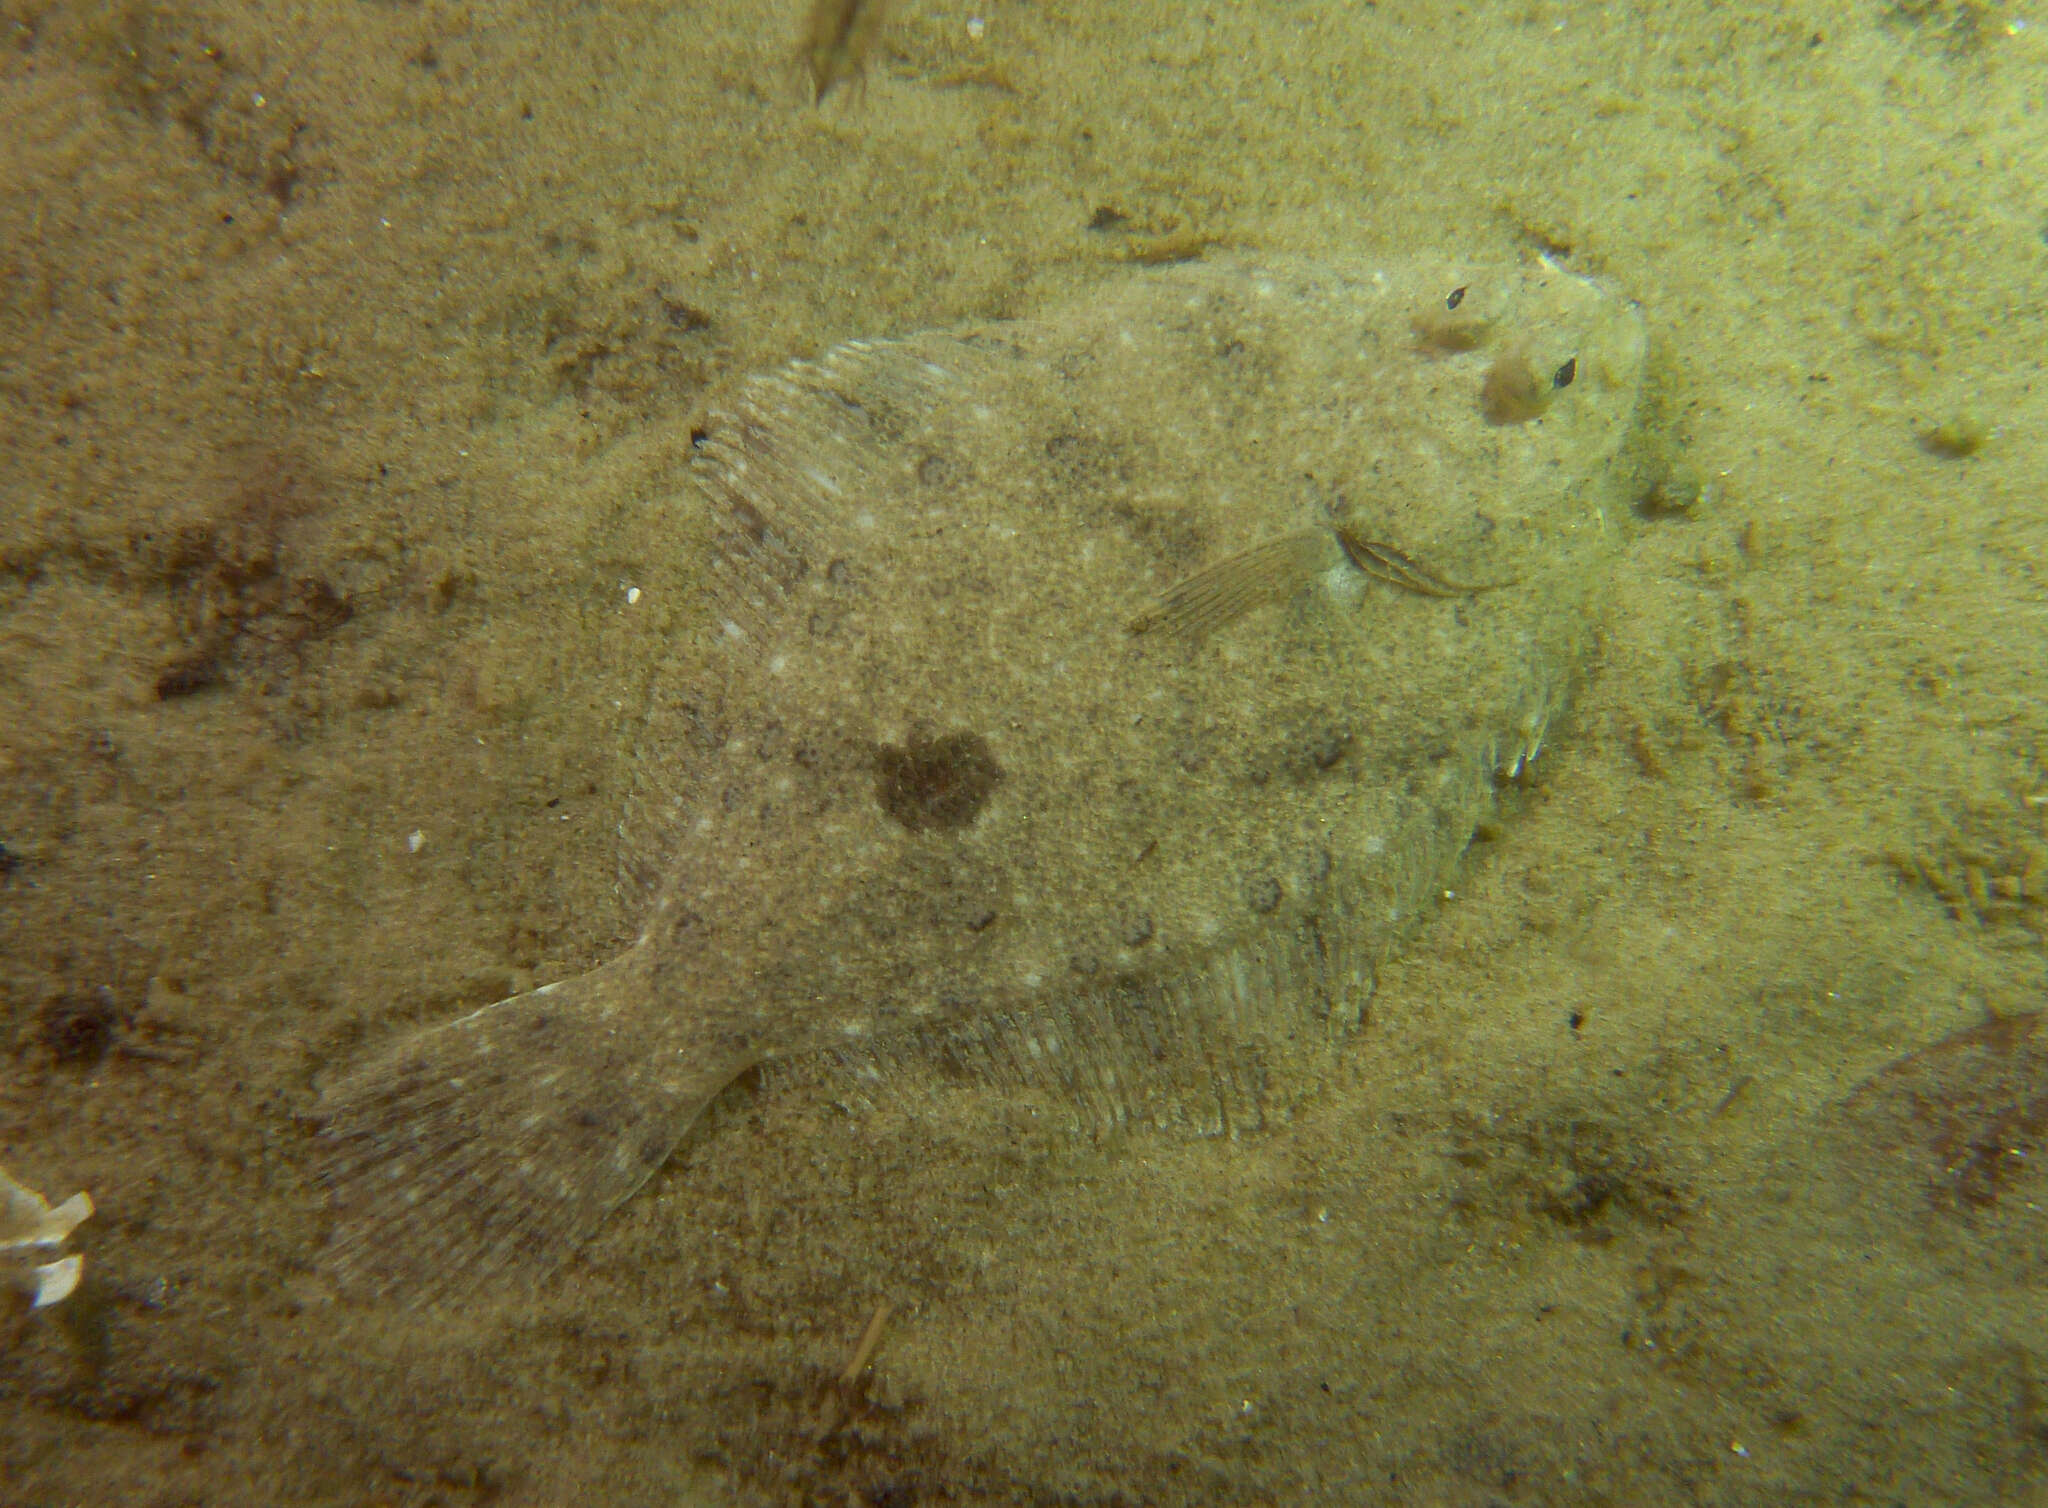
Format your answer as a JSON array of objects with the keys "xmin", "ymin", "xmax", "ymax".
[{"xmin": 0, "ymin": 0, "xmax": 2048, "ymax": 1506}]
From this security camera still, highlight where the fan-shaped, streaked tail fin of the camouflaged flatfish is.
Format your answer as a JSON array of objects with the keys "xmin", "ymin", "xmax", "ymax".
[{"xmin": 317, "ymin": 953, "xmax": 743, "ymax": 1301}]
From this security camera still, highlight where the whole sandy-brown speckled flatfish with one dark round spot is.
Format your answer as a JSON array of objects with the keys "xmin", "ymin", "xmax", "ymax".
[{"xmin": 319, "ymin": 258, "xmax": 1645, "ymax": 1297}]
